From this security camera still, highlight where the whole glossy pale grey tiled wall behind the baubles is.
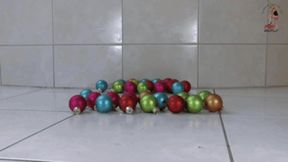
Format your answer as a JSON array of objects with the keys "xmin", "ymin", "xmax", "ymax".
[{"xmin": 0, "ymin": 0, "xmax": 288, "ymax": 87}]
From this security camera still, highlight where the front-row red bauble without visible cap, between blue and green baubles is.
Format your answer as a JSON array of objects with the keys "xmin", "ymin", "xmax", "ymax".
[{"xmin": 168, "ymin": 95, "xmax": 185, "ymax": 113}]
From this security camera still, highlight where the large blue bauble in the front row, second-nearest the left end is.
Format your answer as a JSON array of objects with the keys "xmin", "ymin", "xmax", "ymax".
[{"xmin": 96, "ymin": 94, "xmax": 113, "ymax": 113}]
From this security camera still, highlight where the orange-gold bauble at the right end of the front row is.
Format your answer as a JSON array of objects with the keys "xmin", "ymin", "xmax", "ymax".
[{"xmin": 205, "ymin": 94, "xmax": 223, "ymax": 112}]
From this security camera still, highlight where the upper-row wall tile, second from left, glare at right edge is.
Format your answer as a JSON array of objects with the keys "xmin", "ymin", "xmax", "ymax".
[{"xmin": 53, "ymin": 0, "xmax": 122, "ymax": 44}]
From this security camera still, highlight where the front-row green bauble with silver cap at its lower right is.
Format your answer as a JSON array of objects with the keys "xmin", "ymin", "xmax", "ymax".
[{"xmin": 140, "ymin": 95, "xmax": 158, "ymax": 113}]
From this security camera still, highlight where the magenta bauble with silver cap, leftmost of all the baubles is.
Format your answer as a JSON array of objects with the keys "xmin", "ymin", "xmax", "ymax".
[{"xmin": 69, "ymin": 95, "xmax": 87, "ymax": 114}]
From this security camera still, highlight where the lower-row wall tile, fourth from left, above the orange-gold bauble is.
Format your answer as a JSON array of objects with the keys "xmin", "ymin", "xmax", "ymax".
[{"xmin": 199, "ymin": 45, "xmax": 266, "ymax": 87}]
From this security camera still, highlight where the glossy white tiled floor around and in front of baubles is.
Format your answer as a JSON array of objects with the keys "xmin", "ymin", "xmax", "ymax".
[{"xmin": 0, "ymin": 87, "xmax": 288, "ymax": 162}]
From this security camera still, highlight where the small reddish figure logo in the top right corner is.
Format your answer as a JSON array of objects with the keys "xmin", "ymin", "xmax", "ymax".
[{"xmin": 263, "ymin": 0, "xmax": 282, "ymax": 32}]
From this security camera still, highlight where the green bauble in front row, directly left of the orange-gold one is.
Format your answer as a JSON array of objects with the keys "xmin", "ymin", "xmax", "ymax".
[{"xmin": 186, "ymin": 95, "xmax": 204, "ymax": 113}]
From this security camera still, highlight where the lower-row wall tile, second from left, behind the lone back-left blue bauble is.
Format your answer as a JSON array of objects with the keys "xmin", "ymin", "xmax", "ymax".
[{"xmin": 55, "ymin": 46, "xmax": 122, "ymax": 87}]
